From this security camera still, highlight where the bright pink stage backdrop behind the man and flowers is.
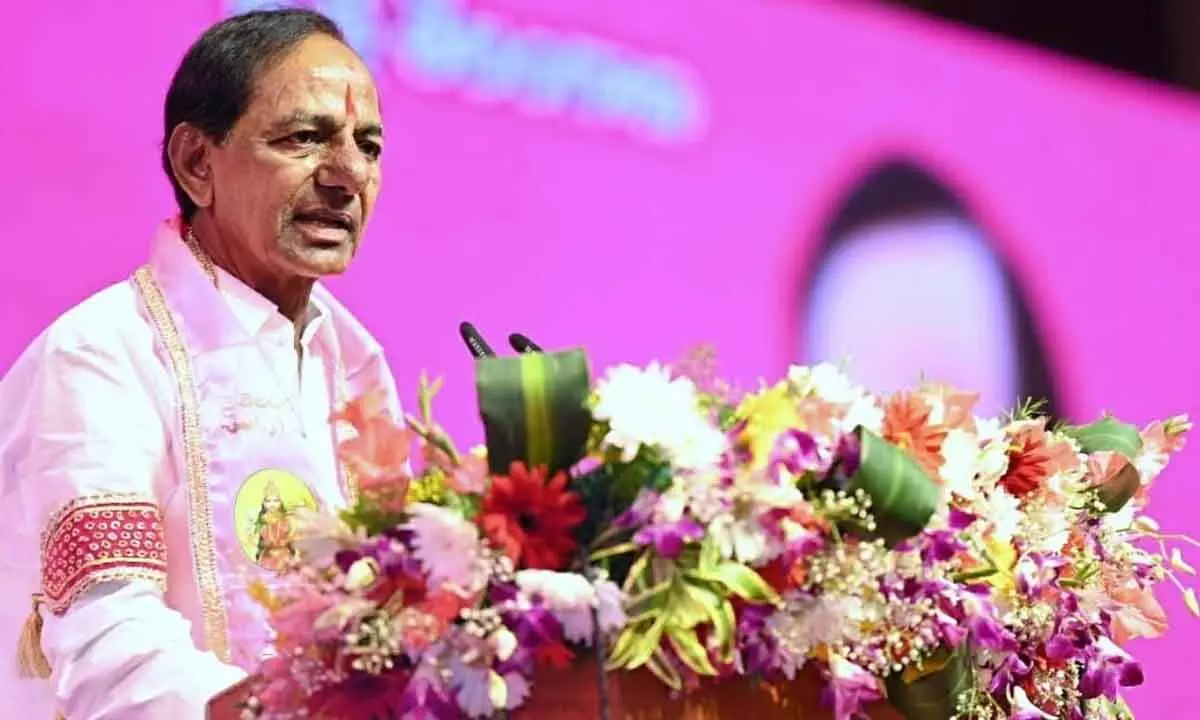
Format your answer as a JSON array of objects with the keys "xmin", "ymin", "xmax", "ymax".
[{"xmin": 0, "ymin": 0, "xmax": 1200, "ymax": 719}]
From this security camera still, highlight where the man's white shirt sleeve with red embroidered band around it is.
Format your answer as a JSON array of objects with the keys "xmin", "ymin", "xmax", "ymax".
[{"xmin": 5, "ymin": 295, "xmax": 244, "ymax": 720}]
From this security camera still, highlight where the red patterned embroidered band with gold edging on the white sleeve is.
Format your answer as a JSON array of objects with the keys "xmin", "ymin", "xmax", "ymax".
[{"xmin": 42, "ymin": 494, "xmax": 167, "ymax": 614}]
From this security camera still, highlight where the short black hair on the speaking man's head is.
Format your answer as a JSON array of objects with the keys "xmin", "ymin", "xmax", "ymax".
[{"xmin": 162, "ymin": 8, "xmax": 346, "ymax": 222}]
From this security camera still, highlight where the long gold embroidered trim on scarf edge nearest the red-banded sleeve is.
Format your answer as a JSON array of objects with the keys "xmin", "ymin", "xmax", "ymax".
[{"xmin": 133, "ymin": 266, "xmax": 230, "ymax": 662}]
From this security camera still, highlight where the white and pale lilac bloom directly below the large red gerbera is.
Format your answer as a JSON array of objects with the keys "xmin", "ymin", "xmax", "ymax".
[{"xmin": 516, "ymin": 570, "xmax": 625, "ymax": 643}]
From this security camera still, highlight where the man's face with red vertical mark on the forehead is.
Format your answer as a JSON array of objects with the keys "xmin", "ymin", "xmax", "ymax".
[{"xmin": 209, "ymin": 35, "xmax": 383, "ymax": 281}]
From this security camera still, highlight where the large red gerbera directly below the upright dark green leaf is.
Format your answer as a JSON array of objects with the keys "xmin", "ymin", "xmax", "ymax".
[{"xmin": 476, "ymin": 462, "xmax": 587, "ymax": 570}]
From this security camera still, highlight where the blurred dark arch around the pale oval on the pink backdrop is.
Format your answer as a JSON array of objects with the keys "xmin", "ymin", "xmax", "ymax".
[{"xmin": 802, "ymin": 158, "xmax": 1062, "ymax": 418}]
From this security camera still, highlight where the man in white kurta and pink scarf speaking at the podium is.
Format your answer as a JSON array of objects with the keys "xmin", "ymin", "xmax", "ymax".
[{"xmin": 0, "ymin": 10, "xmax": 398, "ymax": 720}]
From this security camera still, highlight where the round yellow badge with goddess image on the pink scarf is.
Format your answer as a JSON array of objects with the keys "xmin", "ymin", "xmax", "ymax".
[{"xmin": 234, "ymin": 469, "xmax": 317, "ymax": 571}]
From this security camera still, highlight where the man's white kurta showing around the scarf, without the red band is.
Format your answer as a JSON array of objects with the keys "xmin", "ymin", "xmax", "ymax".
[{"xmin": 0, "ymin": 225, "xmax": 398, "ymax": 720}]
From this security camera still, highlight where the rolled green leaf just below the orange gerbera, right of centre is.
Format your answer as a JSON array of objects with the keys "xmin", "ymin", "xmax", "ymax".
[{"xmin": 847, "ymin": 427, "xmax": 938, "ymax": 545}]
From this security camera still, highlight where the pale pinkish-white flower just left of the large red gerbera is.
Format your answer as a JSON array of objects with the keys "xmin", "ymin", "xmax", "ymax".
[{"xmin": 404, "ymin": 503, "xmax": 487, "ymax": 593}]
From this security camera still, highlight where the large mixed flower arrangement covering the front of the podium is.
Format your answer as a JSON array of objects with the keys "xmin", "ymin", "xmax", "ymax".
[{"xmin": 248, "ymin": 345, "xmax": 1200, "ymax": 720}]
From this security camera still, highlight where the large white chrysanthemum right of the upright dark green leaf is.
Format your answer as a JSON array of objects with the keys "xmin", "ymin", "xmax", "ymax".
[{"xmin": 593, "ymin": 362, "xmax": 726, "ymax": 468}]
